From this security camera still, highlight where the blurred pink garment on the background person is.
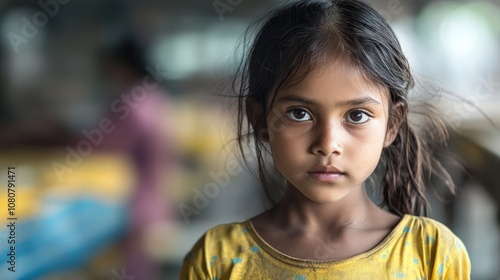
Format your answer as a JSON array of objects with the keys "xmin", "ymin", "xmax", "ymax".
[{"xmin": 76, "ymin": 86, "xmax": 174, "ymax": 279}]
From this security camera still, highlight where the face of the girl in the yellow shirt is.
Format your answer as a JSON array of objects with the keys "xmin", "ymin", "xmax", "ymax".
[{"xmin": 266, "ymin": 60, "xmax": 393, "ymax": 203}]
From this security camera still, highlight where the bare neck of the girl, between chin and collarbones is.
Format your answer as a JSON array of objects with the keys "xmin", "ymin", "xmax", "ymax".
[{"xmin": 273, "ymin": 186, "xmax": 381, "ymax": 233}]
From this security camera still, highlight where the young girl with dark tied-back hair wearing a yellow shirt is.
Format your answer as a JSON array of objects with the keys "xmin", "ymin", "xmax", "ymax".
[{"xmin": 181, "ymin": 0, "xmax": 470, "ymax": 280}]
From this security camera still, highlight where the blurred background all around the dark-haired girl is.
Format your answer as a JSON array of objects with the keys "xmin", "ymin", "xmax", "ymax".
[{"xmin": 0, "ymin": 0, "xmax": 500, "ymax": 280}]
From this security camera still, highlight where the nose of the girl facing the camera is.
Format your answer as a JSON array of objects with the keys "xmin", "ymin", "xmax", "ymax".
[{"xmin": 311, "ymin": 122, "xmax": 344, "ymax": 156}]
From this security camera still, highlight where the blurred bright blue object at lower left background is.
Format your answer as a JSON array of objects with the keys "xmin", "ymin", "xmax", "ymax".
[{"xmin": 0, "ymin": 195, "xmax": 127, "ymax": 280}]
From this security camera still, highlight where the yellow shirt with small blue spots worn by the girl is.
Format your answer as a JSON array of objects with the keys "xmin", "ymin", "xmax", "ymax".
[{"xmin": 181, "ymin": 215, "xmax": 470, "ymax": 280}]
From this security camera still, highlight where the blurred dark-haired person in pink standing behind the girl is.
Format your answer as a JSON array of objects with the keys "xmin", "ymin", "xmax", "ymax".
[{"xmin": 95, "ymin": 38, "xmax": 178, "ymax": 279}]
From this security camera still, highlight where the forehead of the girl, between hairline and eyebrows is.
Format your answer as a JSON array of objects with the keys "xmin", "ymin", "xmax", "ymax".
[{"xmin": 275, "ymin": 60, "xmax": 389, "ymax": 104}]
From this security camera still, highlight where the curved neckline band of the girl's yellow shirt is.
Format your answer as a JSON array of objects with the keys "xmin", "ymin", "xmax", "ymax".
[{"xmin": 245, "ymin": 214, "xmax": 412, "ymax": 268}]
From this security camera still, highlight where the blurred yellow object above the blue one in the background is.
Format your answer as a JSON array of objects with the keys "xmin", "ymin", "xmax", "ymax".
[{"xmin": 0, "ymin": 149, "xmax": 135, "ymax": 220}]
